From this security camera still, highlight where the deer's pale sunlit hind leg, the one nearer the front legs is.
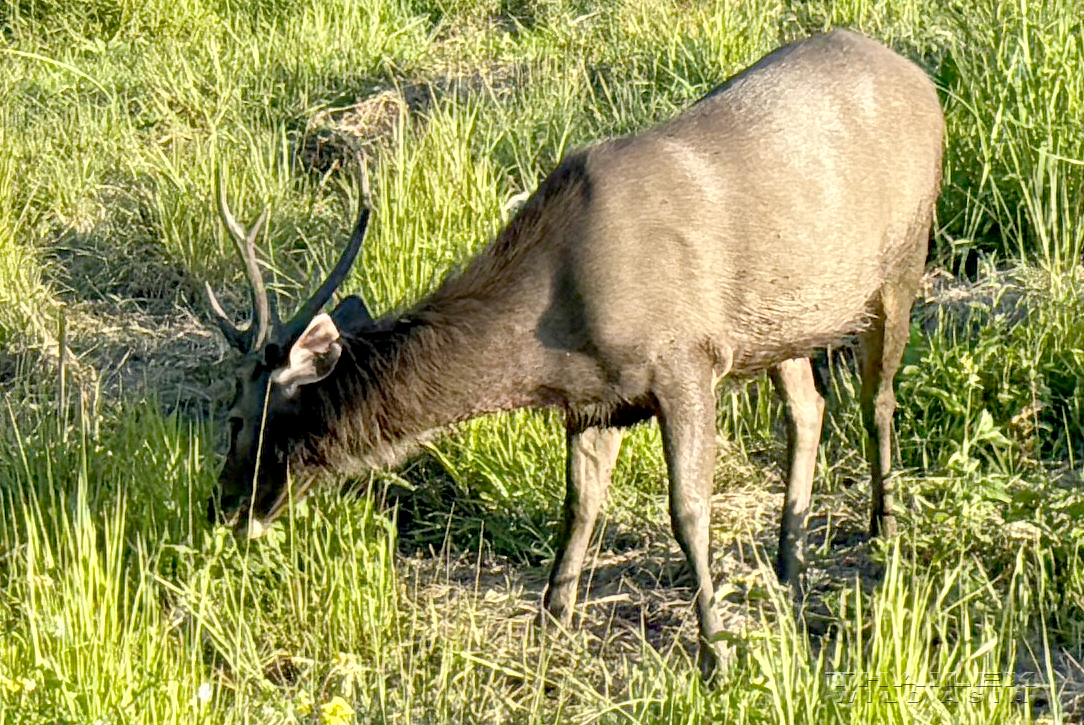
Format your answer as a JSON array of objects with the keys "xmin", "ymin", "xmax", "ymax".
[{"xmin": 771, "ymin": 358, "xmax": 824, "ymax": 585}]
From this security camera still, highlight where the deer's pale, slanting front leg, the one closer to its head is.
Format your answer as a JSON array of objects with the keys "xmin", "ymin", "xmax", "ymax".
[{"xmin": 543, "ymin": 426, "xmax": 622, "ymax": 625}]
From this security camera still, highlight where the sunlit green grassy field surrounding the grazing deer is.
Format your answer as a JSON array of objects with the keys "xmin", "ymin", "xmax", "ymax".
[{"xmin": 0, "ymin": 0, "xmax": 1084, "ymax": 725}]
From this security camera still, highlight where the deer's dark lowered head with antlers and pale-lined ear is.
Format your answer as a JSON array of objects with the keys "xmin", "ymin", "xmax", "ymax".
[{"xmin": 207, "ymin": 174, "xmax": 370, "ymax": 528}]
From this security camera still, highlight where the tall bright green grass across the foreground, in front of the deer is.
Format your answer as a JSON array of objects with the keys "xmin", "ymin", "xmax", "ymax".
[{"xmin": 0, "ymin": 392, "xmax": 1045, "ymax": 723}]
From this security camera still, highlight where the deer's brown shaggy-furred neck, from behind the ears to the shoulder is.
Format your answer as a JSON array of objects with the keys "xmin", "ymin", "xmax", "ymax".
[{"xmin": 291, "ymin": 151, "xmax": 590, "ymax": 471}]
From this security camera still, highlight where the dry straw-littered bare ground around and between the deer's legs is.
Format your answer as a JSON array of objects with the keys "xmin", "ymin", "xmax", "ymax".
[{"xmin": 401, "ymin": 448, "xmax": 877, "ymax": 691}]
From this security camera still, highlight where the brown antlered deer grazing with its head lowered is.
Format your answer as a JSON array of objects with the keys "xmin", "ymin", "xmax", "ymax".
[{"xmin": 207, "ymin": 29, "xmax": 944, "ymax": 675}]
